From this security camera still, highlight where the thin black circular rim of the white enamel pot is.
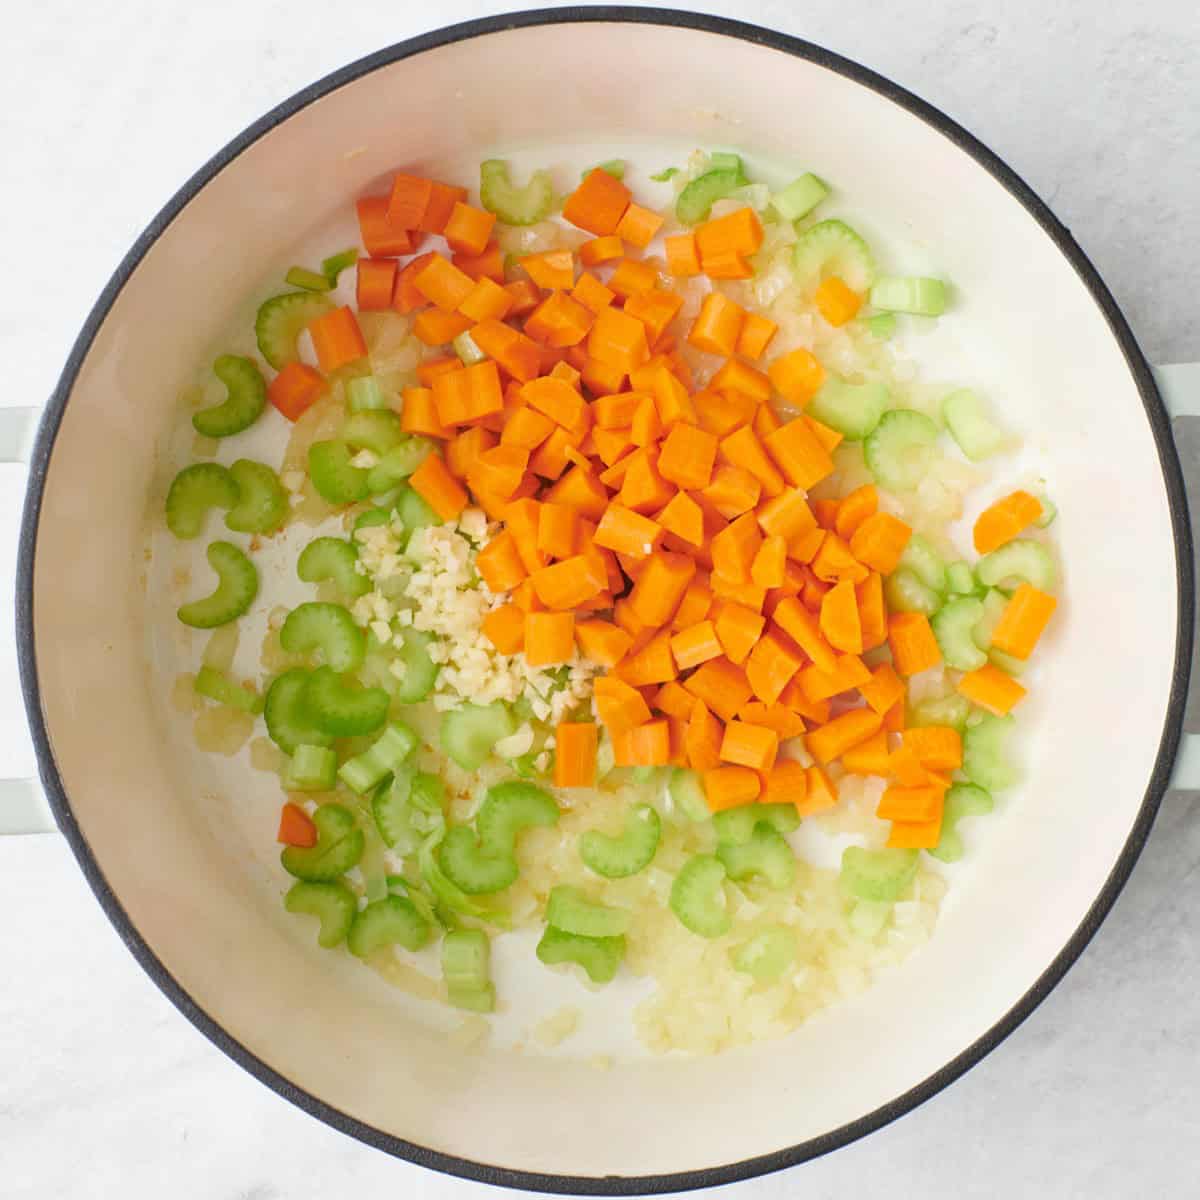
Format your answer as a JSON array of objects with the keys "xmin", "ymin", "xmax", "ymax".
[{"xmin": 16, "ymin": 6, "xmax": 1195, "ymax": 1195}]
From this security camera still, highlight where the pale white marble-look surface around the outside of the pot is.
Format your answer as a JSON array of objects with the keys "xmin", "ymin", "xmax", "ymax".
[{"xmin": 0, "ymin": 0, "xmax": 1200, "ymax": 1200}]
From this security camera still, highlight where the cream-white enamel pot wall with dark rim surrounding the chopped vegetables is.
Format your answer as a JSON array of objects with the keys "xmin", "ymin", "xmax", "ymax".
[{"xmin": 9, "ymin": 8, "xmax": 1200, "ymax": 1193}]
